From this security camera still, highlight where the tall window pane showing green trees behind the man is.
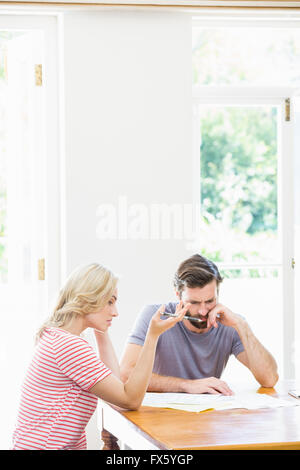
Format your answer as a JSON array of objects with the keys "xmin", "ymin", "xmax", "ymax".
[{"xmin": 199, "ymin": 106, "xmax": 281, "ymax": 264}]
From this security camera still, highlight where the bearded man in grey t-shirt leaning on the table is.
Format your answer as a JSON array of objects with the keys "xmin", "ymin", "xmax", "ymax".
[{"xmin": 120, "ymin": 254, "xmax": 278, "ymax": 395}]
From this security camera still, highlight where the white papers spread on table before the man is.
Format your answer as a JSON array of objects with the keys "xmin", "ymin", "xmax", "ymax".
[{"xmin": 142, "ymin": 392, "xmax": 300, "ymax": 412}]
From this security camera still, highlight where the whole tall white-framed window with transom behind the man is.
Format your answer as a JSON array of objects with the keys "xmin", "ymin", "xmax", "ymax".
[{"xmin": 193, "ymin": 19, "xmax": 300, "ymax": 379}]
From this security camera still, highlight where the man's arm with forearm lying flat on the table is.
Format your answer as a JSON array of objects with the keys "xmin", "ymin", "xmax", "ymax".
[{"xmin": 120, "ymin": 344, "xmax": 233, "ymax": 395}]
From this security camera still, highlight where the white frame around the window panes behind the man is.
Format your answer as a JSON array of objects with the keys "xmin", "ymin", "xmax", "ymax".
[{"xmin": 192, "ymin": 13, "xmax": 300, "ymax": 379}]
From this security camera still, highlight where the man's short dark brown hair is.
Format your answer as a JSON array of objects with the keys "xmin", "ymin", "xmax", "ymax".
[{"xmin": 174, "ymin": 254, "xmax": 223, "ymax": 294}]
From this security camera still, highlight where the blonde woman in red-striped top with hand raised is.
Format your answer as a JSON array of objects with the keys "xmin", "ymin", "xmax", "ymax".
[{"xmin": 13, "ymin": 264, "xmax": 190, "ymax": 449}]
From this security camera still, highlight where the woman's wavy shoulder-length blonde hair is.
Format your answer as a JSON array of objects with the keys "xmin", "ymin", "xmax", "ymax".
[{"xmin": 36, "ymin": 263, "xmax": 118, "ymax": 342}]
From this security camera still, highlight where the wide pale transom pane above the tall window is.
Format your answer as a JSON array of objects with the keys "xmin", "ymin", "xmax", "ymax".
[{"xmin": 193, "ymin": 27, "xmax": 300, "ymax": 86}]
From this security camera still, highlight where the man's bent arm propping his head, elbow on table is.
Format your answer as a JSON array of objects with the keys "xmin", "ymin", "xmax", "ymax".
[{"xmin": 208, "ymin": 304, "xmax": 278, "ymax": 387}]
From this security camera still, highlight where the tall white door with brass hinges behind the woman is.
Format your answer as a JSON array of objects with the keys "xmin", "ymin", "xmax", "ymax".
[{"xmin": 0, "ymin": 30, "xmax": 47, "ymax": 449}]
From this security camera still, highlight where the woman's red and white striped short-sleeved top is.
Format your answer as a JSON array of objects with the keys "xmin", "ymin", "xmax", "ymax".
[{"xmin": 13, "ymin": 328, "xmax": 111, "ymax": 450}]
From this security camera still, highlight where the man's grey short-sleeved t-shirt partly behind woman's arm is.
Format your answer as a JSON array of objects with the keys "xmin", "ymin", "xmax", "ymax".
[{"xmin": 127, "ymin": 302, "xmax": 244, "ymax": 379}]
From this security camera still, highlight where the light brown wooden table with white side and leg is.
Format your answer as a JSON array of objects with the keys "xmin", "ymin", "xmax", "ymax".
[{"xmin": 102, "ymin": 381, "xmax": 300, "ymax": 450}]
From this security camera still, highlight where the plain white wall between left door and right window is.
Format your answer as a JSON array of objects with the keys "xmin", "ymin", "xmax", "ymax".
[{"xmin": 64, "ymin": 11, "xmax": 193, "ymax": 448}]
